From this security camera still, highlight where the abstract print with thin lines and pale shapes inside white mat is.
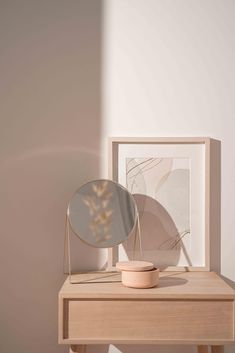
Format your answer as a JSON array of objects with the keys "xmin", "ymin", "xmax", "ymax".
[{"xmin": 125, "ymin": 157, "xmax": 191, "ymax": 265}]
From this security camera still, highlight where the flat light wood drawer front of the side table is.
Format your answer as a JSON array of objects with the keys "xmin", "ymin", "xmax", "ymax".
[{"xmin": 63, "ymin": 299, "xmax": 234, "ymax": 342}]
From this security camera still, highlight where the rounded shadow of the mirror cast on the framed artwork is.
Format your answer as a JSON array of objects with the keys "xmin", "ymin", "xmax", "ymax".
[{"xmin": 123, "ymin": 194, "xmax": 183, "ymax": 270}]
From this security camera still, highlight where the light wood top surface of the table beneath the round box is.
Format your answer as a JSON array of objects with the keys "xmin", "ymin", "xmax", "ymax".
[{"xmin": 59, "ymin": 271, "xmax": 235, "ymax": 300}]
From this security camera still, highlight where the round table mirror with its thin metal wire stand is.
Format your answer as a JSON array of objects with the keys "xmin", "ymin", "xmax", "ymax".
[{"xmin": 63, "ymin": 179, "xmax": 142, "ymax": 283}]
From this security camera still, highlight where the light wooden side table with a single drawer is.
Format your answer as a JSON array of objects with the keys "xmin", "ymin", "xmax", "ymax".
[{"xmin": 59, "ymin": 272, "xmax": 235, "ymax": 353}]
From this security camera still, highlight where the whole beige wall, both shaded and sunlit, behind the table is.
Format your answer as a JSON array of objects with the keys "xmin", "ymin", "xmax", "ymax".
[{"xmin": 0, "ymin": 0, "xmax": 235, "ymax": 353}]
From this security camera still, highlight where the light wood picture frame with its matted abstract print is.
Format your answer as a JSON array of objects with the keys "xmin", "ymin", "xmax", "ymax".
[{"xmin": 108, "ymin": 137, "xmax": 211, "ymax": 271}]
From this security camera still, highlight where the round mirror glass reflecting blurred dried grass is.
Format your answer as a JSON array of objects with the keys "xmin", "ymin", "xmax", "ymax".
[{"xmin": 67, "ymin": 179, "xmax": 137, "ymax": 248}]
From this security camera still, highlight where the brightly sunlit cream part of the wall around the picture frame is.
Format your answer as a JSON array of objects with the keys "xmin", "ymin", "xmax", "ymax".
[{"xmin": 103, "ymin": 0, "xmax": 235, "ymax": 353}]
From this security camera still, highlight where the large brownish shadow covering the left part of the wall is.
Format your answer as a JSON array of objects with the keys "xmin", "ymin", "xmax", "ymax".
[{"xmin": 0, "ymin": 0, "xmax": 103, "ymax": 353}]
